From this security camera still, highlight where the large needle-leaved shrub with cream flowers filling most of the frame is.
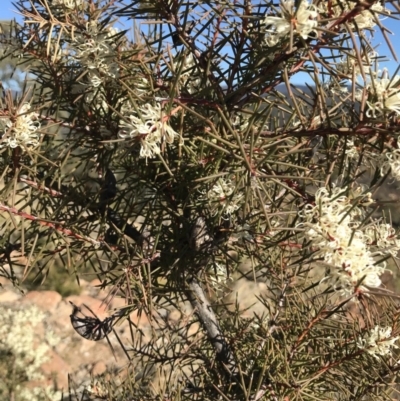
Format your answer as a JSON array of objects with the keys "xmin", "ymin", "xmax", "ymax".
[{"xmin": 0, "ymin": 0, "xmax": 400, "ymax": 400}]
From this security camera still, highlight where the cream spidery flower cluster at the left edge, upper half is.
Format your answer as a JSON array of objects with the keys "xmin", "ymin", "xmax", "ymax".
[{"xmin": 0, "ymin": 103, "xmax": 41, "ymax": 149}]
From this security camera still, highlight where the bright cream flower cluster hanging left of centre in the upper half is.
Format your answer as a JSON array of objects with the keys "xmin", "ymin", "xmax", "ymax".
[{"xmin": 118, "ymin": 103, "xmax": 178, "ymax": 158}]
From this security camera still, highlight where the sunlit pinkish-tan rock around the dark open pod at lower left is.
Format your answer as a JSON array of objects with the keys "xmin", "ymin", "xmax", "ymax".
[{"xmin": 0, "ymin": 288, "xmax": 148, "ymax": 393}]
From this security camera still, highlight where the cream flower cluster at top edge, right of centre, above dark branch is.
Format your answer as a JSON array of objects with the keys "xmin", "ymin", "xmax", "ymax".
[{"xmin": 263, "ymin": 0, "xmax": 318, "ymax": 46}]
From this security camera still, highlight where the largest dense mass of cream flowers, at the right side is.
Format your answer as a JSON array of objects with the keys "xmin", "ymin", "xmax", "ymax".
[{"xmin": 299, "ymin": 188, "xmax": 400, "ymax": 296}]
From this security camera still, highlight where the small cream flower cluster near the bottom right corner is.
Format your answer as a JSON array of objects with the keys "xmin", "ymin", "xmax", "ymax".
[{"xmin": 357, "ymin": 326, "xmax": 399, "ymax": 359}]
